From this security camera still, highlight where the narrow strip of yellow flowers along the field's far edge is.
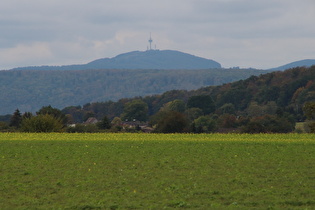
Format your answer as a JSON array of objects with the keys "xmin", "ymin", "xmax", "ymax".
[{"xmin": 0, "ymin": 133, "xmax": 315, "ymax": 143}]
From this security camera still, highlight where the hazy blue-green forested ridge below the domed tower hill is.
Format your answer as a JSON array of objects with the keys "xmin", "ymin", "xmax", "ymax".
[{"xmin": 0, "ymin": 69, "xmax": 268, "ymax": 115}]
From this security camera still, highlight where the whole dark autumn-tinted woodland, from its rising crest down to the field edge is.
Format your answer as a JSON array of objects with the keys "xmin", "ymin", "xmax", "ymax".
[{"xmin": 1, "ymin": 66, "xmax": 315, "ymax": 133}]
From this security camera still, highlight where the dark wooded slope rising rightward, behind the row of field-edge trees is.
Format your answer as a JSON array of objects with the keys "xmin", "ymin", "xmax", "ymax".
[{"xmin": 73, "ymin": 66, "xmax": 315, "ymax": 122}]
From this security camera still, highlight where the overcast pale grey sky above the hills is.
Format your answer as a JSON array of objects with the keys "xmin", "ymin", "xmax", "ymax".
[{"xmin": 0, "ymin": 0, "xmax": 315, "ymax": 69}]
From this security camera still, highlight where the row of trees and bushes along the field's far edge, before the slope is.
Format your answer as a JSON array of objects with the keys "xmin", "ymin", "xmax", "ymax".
[{"xmin": 0, "ymin": 98, "xmax": 315, "ymax": 133}]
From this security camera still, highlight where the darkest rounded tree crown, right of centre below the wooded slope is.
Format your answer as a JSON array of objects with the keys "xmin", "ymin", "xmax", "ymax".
[{"xmin": 187, "ymin": 95, "xmax": 215, "ymax": 115}]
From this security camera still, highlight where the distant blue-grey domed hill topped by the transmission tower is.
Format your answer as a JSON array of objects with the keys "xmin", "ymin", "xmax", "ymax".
[{"xmin": 13, "ymin": 50, "xmax": 221, "ymax": 70}]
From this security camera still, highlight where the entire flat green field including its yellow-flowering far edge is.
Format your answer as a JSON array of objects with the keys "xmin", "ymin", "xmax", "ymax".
[{"xmin": 0, "ymin": 133, "xmax": 315, "ymax": 209}]
